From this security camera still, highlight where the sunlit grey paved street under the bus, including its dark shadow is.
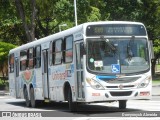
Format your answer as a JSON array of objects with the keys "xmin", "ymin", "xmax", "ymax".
[{"xmin": 0, "ymin": 85, "xmax": 160, "ymax": 120}]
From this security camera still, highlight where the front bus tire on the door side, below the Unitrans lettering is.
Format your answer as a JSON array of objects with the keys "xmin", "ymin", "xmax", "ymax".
[{"xmin": 68, "ymin": 88, "xmax": 77, "ymax": 112}]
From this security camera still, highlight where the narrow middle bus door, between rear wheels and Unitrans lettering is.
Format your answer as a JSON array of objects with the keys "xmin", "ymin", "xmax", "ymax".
[{"xmin": 42, "ymin": 50, "xmax": 49, "ymax": 99}]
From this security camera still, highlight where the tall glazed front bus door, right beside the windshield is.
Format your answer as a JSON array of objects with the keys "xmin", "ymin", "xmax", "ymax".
[{"xmin": 75, "ymin": 42, "xmax": 84, "ymax": 100}]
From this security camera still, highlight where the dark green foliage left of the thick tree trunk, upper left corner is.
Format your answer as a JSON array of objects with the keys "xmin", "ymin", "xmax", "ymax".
[{"xmin": 0, "ymin": 0, "xmax": 26, "ymax": 45}]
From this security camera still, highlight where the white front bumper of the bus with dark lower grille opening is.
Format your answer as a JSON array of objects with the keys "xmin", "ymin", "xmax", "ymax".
[{"xmin": 85, "ymin": 87, "xmax": 152, "ymax": 102}]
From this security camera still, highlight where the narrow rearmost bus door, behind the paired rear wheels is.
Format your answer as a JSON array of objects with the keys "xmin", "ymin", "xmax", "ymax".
[{"xmin": 14, "ymin": 57, "xmax": 21, "ymax": 98}]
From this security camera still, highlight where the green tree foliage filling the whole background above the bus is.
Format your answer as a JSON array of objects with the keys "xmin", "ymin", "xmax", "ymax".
[{"xmin": 0, "ymin": 0, "xmax": 160, "ymax": 75}]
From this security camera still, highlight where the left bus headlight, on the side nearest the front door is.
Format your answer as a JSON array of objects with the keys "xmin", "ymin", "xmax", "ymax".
[{"xmin": 86, "ymin": 78, "xmax": 104, "ymax": 90}]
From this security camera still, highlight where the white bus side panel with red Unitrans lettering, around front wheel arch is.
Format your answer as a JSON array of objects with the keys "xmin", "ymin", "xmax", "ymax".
[{"xmin": 49, "ymin": 64, "xmax": 75, "ymax": 101}]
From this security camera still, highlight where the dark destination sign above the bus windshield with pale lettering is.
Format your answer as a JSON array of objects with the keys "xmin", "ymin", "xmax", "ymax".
[{"xmin": 86, "ymin": 24, "xmax": 146, "ymax": 36}]
